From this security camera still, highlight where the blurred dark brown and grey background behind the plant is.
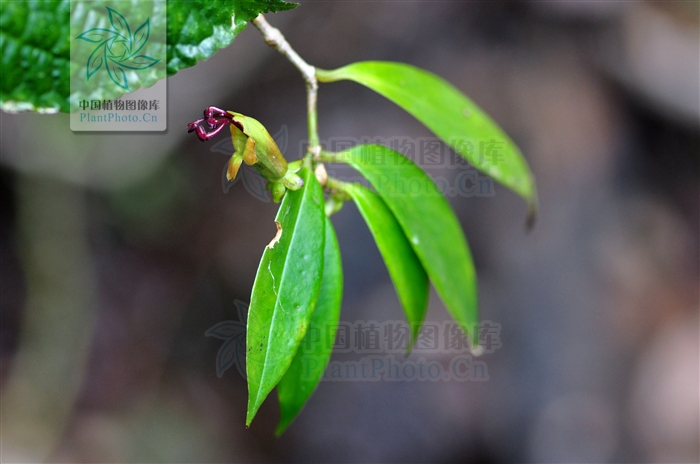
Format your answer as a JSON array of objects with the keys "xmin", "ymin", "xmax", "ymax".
[{"xmin": 0, "ymin": 1, "xmax": 700, "ymax": 463}]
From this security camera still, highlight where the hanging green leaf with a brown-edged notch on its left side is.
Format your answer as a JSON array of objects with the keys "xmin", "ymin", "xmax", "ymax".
[{"xmin": 246, "ymin": 168, "xmax": 326, "ymax": 425}]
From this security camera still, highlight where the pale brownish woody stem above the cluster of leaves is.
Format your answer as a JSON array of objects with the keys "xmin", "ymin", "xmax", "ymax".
[{"xmin": 253, "ymin": 14, "xmax": 321, "ymax": 158}]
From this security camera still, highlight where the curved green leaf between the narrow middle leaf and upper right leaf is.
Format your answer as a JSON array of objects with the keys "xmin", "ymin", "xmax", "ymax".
[{"xmin": 322, "ymin": 145, "xmax": 479, "ymax": 346}]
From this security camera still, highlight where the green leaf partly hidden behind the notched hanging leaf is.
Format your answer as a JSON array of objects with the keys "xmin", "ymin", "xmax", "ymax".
[{"xmin": 277, "ymin": 218, "xmax": 343, "ymax": 435}]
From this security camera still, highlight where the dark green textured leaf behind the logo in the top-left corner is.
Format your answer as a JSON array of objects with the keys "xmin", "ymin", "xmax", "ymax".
[{"xmin": 0, "ymin": 0, "xmax": 298, "ymax": 113}]
